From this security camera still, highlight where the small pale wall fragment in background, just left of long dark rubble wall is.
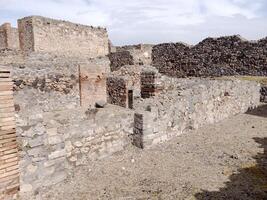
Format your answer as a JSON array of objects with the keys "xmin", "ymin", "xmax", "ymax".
[{"xmin": 116, "ymin": 44, "xmax": 153, "ymax": 65}]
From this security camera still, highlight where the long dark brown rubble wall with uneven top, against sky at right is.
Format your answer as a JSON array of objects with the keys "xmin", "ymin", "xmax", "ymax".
[{"xmin": 152, "ymin": 36, "xmax": 267, "ymax": 77}]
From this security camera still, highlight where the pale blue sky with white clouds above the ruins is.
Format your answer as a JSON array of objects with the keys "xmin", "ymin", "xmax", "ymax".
[{"xmin": 0, "ymin": 0, "xmax": 267, "ymax": 45}]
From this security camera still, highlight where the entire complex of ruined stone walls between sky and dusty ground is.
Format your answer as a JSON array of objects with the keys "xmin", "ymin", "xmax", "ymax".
[{"xmin": 0, "ymin": 16, "xmax": 267, "ymax": 199}]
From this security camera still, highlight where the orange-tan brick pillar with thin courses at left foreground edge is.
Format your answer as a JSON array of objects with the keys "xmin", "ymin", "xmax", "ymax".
[{"xmin": 0, "ymin": 66, "xmax": 19, "ymax": 199}]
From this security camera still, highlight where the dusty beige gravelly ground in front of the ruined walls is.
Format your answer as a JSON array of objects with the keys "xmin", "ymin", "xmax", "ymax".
[{"xmin": 29, "ymin": 105, "xmax": 267, "ymax": 200}]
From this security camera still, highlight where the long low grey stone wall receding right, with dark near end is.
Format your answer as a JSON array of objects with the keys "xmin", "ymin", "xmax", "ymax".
[{"xmin": 133, "ymin": 79, "xmax": 260, "ymax": 148}]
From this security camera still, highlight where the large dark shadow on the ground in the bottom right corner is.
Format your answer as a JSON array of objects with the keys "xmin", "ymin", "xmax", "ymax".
[{"xmin": 195, "ymin": 137, "xmax": 267, "ymax": 200}]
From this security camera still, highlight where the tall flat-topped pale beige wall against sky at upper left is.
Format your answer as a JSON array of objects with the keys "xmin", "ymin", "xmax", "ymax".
[{"xmin": 18, "ymin": 16, "xmax": 109, "ymax": 57}]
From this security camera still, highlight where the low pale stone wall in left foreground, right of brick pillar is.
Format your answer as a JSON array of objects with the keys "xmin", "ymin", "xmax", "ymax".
[{"xmin": 18, "ymin": 105, "xmax": 133, "ymax": 193}]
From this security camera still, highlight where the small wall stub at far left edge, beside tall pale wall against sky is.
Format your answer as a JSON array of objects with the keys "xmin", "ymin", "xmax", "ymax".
[{"xmin": 0, "ymin": 23, "xmax": 19, "ymax": 49}]
